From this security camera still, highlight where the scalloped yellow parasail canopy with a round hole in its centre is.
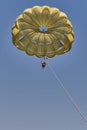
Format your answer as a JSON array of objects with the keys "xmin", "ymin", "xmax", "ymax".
[{"xmin": 12, "ymin": 6, "xmax": 74, "ymax": 58}]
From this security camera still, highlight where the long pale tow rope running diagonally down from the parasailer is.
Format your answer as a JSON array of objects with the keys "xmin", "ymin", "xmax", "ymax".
[{"xmin": 48, "ymin": 64, "xmax": 87, "ymax": 123}]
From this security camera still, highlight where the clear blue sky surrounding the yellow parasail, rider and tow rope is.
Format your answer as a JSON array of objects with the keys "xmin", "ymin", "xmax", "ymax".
[{"xmin": 0, "ymin": 0, "xmax": 87, "ymax": 130}]
